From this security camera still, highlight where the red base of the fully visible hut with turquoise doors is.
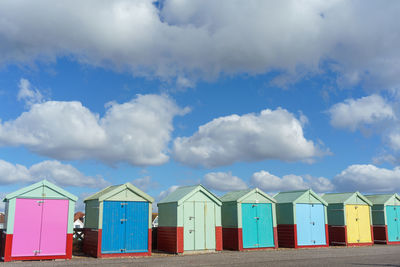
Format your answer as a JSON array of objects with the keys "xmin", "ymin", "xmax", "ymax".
[{"xmin": 222, "ymin": 227, "xmax": 278, "ymax": 251}]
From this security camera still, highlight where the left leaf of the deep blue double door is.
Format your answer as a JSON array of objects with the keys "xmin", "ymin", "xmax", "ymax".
[{"xmin": 101, "ymin": 201, "xmax": 126, "ymax": 253}]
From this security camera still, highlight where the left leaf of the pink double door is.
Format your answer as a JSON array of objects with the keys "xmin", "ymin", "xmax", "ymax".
[{"xmin": 11, "ymin": 199, "xmax": 42, "ymax": 257}]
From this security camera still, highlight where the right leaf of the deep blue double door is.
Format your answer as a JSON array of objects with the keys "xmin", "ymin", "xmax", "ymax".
[{"xmin": 125, "ymin": 202, "xmax": 149, "ymax": 253}]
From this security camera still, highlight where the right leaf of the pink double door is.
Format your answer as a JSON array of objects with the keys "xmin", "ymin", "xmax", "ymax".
[{"xmin": 39, "ymin": 199, "xmax": 68, "ymax": 256}]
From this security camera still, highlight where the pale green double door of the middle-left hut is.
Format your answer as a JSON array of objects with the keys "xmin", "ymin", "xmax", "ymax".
[{"xmin": 183, "ymin": 201, "xmax": 216, "ymax": 250}]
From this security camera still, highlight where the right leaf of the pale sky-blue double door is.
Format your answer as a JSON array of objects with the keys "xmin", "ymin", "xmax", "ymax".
[{"xmin": 310, "ymin": 204, "xmax": 326, "ymax": 245}]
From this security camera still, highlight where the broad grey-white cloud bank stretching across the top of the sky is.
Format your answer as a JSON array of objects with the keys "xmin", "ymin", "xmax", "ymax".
[{"xmin": 0, "ymin": 0, "xmax": 400, "ymax": 88}]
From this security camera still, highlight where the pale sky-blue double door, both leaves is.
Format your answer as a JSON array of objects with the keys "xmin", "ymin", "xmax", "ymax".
[{"xmin": 296, "ymin": 204, "xmax": 326, "ymax": 246}]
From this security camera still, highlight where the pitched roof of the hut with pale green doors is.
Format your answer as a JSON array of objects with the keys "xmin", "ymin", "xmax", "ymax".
[{"xmin": 158, "ymin": 184, "xmax": 222, "ymax": 205}]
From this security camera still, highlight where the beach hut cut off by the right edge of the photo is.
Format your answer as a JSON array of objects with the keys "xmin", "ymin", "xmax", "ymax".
[{"xmin": 365, "ymin": 194, "xmax": 400, "ymax": 245}]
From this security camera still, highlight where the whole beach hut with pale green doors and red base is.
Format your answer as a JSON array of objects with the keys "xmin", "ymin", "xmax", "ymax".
[{"xmin": 157, "ymin": 185, "xmax": 222, "ymax": 253}]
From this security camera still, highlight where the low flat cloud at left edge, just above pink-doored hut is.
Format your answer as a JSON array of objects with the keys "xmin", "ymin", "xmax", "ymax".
[{"xmin": 0, "ymin": 160, "xmax": 109, "ymax": 188}]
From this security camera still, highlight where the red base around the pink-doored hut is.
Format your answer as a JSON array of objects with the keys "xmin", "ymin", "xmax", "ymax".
[{"xmin": 1, "ymin": 233, "xmax": 73, "ymax": 262}]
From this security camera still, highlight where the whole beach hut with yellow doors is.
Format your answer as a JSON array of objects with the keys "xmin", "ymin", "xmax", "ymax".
[{"xmin": 322, "ymin": 192, "xmax": 373, "ymax": 246}]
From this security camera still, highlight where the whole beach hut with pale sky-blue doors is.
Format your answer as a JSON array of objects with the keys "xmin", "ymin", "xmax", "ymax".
[{"xmin": 274, "ymin": 189, "xmax": 328, "ymax": 248}]
